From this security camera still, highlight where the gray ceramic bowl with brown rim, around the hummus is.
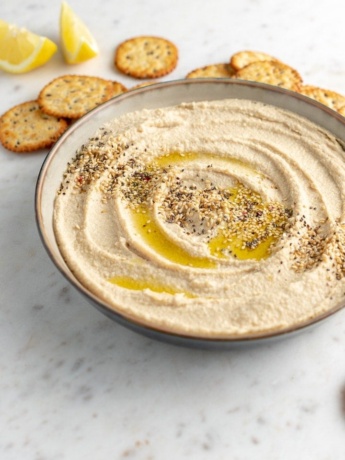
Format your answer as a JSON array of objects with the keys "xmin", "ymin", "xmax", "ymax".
[{"xmin": 36, "ymin": 79, "xmax": 345, "ymax": 349}]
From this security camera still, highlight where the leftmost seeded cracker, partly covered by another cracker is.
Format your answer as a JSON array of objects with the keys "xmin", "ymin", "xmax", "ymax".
[{"xmin": 0, "ymin": 101, "xmax": 68, "ymax": 152}]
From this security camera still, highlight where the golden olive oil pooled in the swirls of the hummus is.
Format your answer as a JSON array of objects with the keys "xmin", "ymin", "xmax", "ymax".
[{"xmin": 109, "ymin": 152, "xmax": 292, "ymax": 296}]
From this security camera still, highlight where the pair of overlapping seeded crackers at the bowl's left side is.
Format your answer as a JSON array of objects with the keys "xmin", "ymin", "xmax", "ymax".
[{"xmin": 0, "ymin": 75, "xmax": 126, "ymax": 153}]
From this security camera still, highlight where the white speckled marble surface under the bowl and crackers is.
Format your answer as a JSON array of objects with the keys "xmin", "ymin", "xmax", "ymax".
[{"xmin": 0, "ymin": 0, "xmax": 345, "ymax": 460}]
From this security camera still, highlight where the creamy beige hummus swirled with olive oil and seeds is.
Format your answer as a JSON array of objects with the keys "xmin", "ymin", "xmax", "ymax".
[{"xmin": 54, "ymin": 99, "xmax": 345, "ymax": 338}]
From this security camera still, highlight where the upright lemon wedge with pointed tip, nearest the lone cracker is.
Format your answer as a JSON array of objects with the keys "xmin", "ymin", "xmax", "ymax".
[{"xmin": 60, "ymin": 2, "xmax": 98, "ymax": 64}]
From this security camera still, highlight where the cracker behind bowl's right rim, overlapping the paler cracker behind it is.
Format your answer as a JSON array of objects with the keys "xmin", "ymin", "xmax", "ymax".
[{"xmin": 235, "ymin": 61, "xmax": 302, "ymax": 91}]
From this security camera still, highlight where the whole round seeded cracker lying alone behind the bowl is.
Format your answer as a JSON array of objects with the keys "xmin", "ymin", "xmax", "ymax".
[{"xmin": 114, "ymin": 36, "xmax": 178, "ymax": 78}]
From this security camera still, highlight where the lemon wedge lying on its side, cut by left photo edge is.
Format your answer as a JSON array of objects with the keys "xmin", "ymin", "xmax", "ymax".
[{"xmin": 0, "ymin": 19, "xmax": 57, "ymax": 73}]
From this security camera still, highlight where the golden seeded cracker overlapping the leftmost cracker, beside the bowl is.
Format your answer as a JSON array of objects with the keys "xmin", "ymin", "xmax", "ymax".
[{"xmin": 38, "ymin": 75, "xmax": 114, "ymax": 119}]
